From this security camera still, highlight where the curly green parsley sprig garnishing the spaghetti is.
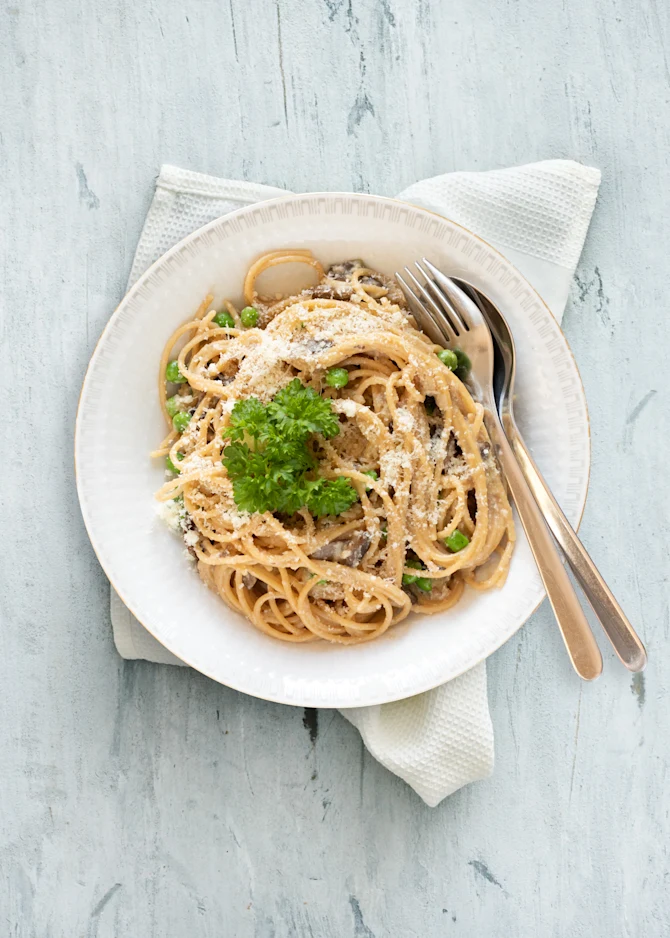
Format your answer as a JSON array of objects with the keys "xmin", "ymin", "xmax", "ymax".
[{"xmin": 223, "ymin": 378, "xmax": 358, "ymax": 517}]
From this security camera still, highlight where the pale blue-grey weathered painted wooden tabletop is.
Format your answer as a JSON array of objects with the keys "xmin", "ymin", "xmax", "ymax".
[{"xmin": 0, "ymin": 0, "xmax": 670, "ymax": 938}]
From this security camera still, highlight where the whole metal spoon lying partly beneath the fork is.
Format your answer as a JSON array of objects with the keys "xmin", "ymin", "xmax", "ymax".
[{"xmin": 455, "ymin": 281, "xmax": 647, "ymax": 671}]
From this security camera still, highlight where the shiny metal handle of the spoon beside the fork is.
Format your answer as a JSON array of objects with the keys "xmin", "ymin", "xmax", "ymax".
[{"xmin": 504, "ymin": 419, "xmax": 647, "ymax": 671}]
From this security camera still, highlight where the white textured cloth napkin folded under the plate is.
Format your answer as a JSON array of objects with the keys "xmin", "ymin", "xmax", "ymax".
[{"xmin": 111, "ymin": 160, "xmax": 600, "ymax": 806}]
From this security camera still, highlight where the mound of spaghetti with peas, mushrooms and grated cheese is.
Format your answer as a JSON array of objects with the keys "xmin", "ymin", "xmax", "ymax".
[{"xmin": 153, "ymin": 250, "xmax": 514, "ymax": 644}]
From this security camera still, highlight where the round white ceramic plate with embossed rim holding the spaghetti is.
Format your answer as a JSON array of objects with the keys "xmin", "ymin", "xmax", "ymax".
[{"xmin": 75, "ymin": 193, "xmax": 589, "ymax": 707}]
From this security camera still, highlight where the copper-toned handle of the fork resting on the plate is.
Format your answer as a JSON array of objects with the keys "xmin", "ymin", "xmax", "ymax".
[{"xmin": 486, "ymin": 410, "xmax": 603, "ymax": 681}]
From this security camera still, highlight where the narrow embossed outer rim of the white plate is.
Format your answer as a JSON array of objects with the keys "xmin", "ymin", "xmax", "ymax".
[{"xmin": 73, "ymin": 190, "xmax": 592, "ymax": 710}]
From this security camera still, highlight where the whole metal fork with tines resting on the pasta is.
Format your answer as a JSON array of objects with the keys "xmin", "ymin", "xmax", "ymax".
[{"xmin": 396, "ymin": 257, "xmax": 603, "ymax": 681}]
